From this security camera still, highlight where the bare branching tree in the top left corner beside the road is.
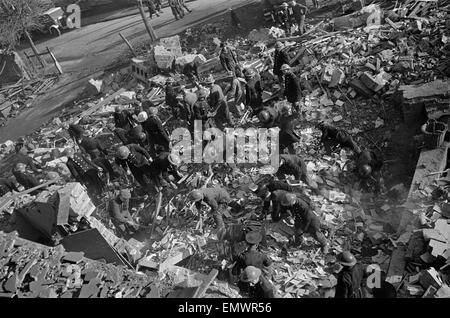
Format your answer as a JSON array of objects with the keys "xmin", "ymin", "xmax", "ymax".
[{"xmin": 0, "ymin": 0, "xmax": 53, "ymax": 54}]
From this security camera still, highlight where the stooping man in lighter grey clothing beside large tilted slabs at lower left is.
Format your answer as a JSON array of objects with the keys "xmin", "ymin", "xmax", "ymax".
[{"xmin": 109, "ymin": 189, "xmax": 139, "ymax": 234}]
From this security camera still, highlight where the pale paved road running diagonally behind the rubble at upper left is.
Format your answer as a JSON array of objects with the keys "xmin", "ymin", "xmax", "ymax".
[{"xmin": 0, "ymin": 0, "xmax": 257, "ymax": 143}]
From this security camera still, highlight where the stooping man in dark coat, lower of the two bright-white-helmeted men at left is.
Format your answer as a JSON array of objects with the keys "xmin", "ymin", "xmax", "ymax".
[{"xmin": 116, "ymin": 144, "xmax": 152, "ymax": 189}]
